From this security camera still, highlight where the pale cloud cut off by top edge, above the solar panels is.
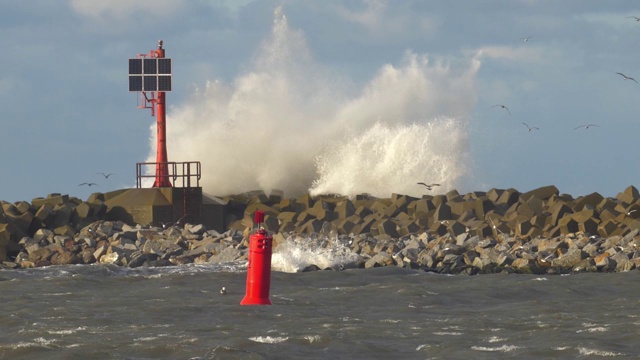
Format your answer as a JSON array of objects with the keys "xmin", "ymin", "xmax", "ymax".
[{"xmin": 69, "ymin": 0, "xmax": 187, "ymax": 19}]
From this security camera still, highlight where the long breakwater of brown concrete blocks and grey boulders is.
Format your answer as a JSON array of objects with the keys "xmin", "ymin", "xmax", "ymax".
[{"xmin": 0, "ymin": 186, "xmax": 640, "ymax": 274}]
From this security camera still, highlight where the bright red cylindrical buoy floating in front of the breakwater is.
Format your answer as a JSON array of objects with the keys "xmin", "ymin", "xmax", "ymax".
[{"xmin": 240, "ymin": 210, "xmax": 273, "ymax": 305}]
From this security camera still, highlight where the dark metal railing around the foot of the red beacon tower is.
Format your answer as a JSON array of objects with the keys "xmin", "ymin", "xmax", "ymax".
[{"xmin": 136, "ymin": 161, "xmax": 201, "ymax": 189}]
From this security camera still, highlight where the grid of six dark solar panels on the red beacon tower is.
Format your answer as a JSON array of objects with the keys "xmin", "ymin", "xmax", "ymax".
[{"xmin": 129, "ymin": 58, "xmax": 171, "ymax": 91}]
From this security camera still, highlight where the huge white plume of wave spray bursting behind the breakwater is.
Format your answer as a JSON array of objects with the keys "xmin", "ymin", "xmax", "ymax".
[{"xmin": 148, "ymin": 8, "xmax": 480, "ymax": 197}]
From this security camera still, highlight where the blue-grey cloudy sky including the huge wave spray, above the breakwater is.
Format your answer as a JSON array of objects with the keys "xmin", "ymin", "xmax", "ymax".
[{"xmin": 0, "ymin": 0, "xmax": 640, "ymax": 202}]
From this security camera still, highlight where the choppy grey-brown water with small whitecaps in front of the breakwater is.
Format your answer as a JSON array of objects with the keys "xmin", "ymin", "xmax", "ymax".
[{"xmin": 0, "ymin": 265, "xmax": 640, "ymax": 359}]
